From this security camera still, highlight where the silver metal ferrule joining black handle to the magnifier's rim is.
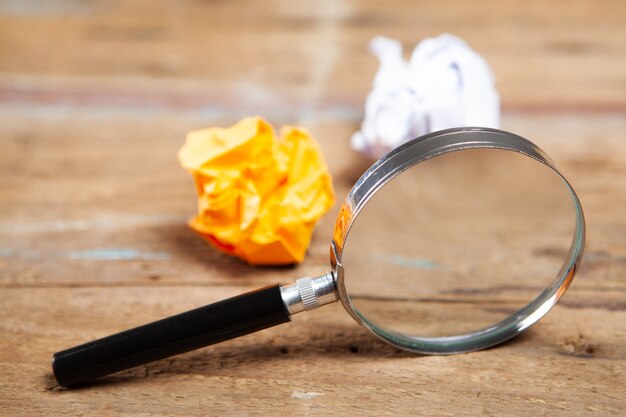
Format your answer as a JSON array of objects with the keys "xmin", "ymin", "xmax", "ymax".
[{"xmin": 280, "ymin": 272, "xmax": 337, "ymax": 315}]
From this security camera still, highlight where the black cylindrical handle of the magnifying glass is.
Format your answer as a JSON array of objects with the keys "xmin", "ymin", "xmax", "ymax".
[{"xmin": 52, "ymin": 285, "xmax": 290, "ymax": 387}]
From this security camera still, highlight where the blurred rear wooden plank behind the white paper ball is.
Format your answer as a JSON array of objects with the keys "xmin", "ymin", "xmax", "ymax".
[{"xmin": 0, "ymin": 0, "xmax": 626, "ymax": 114}]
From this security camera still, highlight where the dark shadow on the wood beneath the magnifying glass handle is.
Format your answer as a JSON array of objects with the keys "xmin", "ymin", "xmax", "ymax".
[{"xmin": 45, "ymin": 324, "xmax": 532, "ymax": 391}]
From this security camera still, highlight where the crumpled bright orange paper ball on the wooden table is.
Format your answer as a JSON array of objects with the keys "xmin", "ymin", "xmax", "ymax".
[{"xmin": 178, "ymin": 117, "xmax": 335, "ymax": 265}]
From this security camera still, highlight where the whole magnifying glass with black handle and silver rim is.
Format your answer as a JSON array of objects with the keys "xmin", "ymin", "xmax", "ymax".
[{"xmin": 52, "ymin": 128, "xmax": 585, "ymax": 387}]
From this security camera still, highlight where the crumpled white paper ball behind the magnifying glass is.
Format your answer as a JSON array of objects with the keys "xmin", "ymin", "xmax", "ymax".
[{"xmin": 351, "ymin": 33, "xmax": 500, "ymax": 158}]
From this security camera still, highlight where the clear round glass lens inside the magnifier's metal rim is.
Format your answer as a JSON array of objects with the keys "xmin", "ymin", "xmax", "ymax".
[{"xmin": 341, "ymin": 149, "xmax": 576, "ymax": 337}]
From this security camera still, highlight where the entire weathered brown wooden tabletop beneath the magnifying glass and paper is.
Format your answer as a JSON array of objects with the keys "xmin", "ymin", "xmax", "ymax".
[{"xmin": 0, "ymin": 0, "xmax": 626, "ymax": 416}]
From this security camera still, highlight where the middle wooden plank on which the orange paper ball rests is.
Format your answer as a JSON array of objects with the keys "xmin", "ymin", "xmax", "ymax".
[{"xmin": 0, "ymin": 109, "xmax": 626, "ymax": 288}]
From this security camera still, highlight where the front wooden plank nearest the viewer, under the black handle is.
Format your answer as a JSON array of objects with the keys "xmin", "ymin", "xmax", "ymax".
[{"xmin": 0, "ymin": 287, "xmax": 626, "ymax": 416}]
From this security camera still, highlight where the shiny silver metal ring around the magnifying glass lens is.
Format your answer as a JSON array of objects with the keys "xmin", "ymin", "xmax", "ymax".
[{"xmin": 331, "ymin": 127, "xmax": 585, "ymax": 354}]
